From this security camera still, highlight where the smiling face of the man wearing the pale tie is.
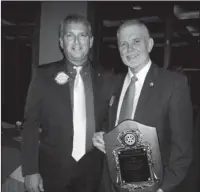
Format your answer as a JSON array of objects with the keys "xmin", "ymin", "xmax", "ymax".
[{"xmin": 60, "ymin": 22, "xmax": 93, "ymax": 66}]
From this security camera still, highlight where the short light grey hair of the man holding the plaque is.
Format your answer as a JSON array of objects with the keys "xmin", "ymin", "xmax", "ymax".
[{"xmin": 117, "ymin": 19, "xmax": 150, "ymax": 38}]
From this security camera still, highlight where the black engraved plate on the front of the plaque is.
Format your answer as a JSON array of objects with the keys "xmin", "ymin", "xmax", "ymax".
[{"xmin": 118, "ymin": 148, "xmax": 151, "ymax": 183}]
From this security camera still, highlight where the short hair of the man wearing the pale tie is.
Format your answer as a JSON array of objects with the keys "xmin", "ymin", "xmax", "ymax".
[{"xmin": 59, "ymin": 14, "xmax": 92, "ymax": 37}]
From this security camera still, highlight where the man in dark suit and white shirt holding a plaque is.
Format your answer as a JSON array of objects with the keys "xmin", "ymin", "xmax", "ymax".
[{"xmin": 93, "ymin": 20, "xmax": 193, "ymax": 192}]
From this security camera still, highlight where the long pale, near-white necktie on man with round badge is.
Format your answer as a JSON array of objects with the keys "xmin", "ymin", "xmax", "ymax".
[{"xmin": 72, "ymin": 67, "xmax": 86, "ymax": 161}]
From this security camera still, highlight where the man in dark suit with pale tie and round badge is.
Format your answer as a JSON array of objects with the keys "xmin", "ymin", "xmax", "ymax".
[{"xmin": 22, "ymin": 15, "xmax": 114, "ymax": 192}]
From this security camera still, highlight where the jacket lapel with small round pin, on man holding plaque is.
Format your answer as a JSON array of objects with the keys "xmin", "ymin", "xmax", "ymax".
[{"xmin": 134, "ymin": 64, "xmax": 158, "ymax": 121}]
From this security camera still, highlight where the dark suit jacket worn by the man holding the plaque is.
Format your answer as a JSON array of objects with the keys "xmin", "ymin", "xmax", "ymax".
[{"xmin": 103, "ymin": 64, "xmax": 193, "ymax": 192}]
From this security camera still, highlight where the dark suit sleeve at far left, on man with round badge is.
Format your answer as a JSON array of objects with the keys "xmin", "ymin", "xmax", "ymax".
[{"xmin": 21, "ymin": 69, "xmax": 42, "ymax": 176}]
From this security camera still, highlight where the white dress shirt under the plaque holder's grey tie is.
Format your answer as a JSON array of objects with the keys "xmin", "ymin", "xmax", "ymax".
[{"xmin": 115, "ymin": 60, "xmax": 151, "ymax": 126}]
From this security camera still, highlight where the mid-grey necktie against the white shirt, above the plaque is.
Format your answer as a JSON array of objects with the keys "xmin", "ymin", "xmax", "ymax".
[{"xmin": 118, "ymin": 75, "xmax": 137, "ymax": 123}]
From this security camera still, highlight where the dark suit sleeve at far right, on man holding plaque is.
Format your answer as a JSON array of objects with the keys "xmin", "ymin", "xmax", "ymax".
[{"xmin": 161, "ymin": 76, "xmax": 193, "ymax": 192}]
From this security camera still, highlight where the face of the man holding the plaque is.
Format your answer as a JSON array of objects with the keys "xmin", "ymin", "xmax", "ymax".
[{"xmin": 118, "ymin": 25, "xmax": 153, "ymax": 73}]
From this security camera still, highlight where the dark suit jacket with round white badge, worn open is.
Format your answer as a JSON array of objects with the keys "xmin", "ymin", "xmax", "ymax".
[{"xmin": 22, "ymin": 60, "xmax": 111, "ymax": 184}]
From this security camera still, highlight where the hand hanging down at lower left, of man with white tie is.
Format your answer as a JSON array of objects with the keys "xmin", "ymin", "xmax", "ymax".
[{"xmin": 24, "ymin": 173, "xmax": 44, "ymax": 192}]
